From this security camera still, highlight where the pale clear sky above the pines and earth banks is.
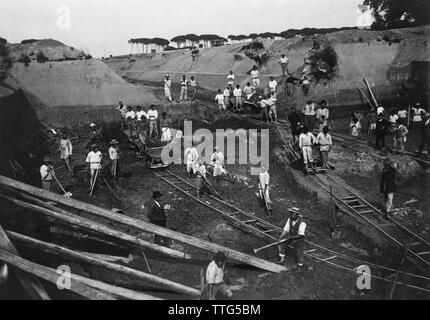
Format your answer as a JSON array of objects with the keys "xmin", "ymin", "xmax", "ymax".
[{"xmin": 0, "ymin": 0, "xmax": 363, "ymax": 57}]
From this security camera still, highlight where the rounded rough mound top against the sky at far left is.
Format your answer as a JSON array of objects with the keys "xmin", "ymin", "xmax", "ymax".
[{"xmin": 6, "ymin": 39, "xmax": 85, "ymax": 61}]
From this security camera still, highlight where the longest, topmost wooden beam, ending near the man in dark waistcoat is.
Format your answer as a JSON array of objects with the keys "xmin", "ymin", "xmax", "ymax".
[{"xmin": 0, "ymin": 175, "xmax": 286, "ymax": 273}]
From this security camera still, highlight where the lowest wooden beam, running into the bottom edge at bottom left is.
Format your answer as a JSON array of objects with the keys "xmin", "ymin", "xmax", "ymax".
[{"xmin": 0, "ymin": 249, "xmax": 117, "ymax": 300}]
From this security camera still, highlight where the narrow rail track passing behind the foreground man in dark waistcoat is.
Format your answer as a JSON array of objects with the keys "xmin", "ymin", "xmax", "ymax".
[{"xmin": 153, "ymin": 169, "xmax": 430, "ymax": 293}]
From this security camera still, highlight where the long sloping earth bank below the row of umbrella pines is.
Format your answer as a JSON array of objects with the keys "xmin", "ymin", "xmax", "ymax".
[{"xmin": 104, "ymin": 27, "xmax": 430, "ymax": 105}]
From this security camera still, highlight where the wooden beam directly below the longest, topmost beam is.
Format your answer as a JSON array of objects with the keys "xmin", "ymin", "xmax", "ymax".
[{"xmin": 6, "ymin": 194, "xmax": 191, "ymax": 259}]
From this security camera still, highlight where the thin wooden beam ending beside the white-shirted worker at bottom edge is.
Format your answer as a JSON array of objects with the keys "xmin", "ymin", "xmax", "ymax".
[{"xmin": 7, "ymin": 231, "xmax": 200, "ymax": 296}]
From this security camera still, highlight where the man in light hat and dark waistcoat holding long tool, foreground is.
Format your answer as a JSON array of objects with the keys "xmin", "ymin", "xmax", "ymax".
[{"xmin": 278, "ymin": 207, "xmax": 306, "ymax": 268}]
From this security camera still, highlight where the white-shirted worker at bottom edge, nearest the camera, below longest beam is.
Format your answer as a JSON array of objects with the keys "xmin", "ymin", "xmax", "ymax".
[{"xmin": 205, "ymin": 251, "xmax": 233, "ymax": 300}]
